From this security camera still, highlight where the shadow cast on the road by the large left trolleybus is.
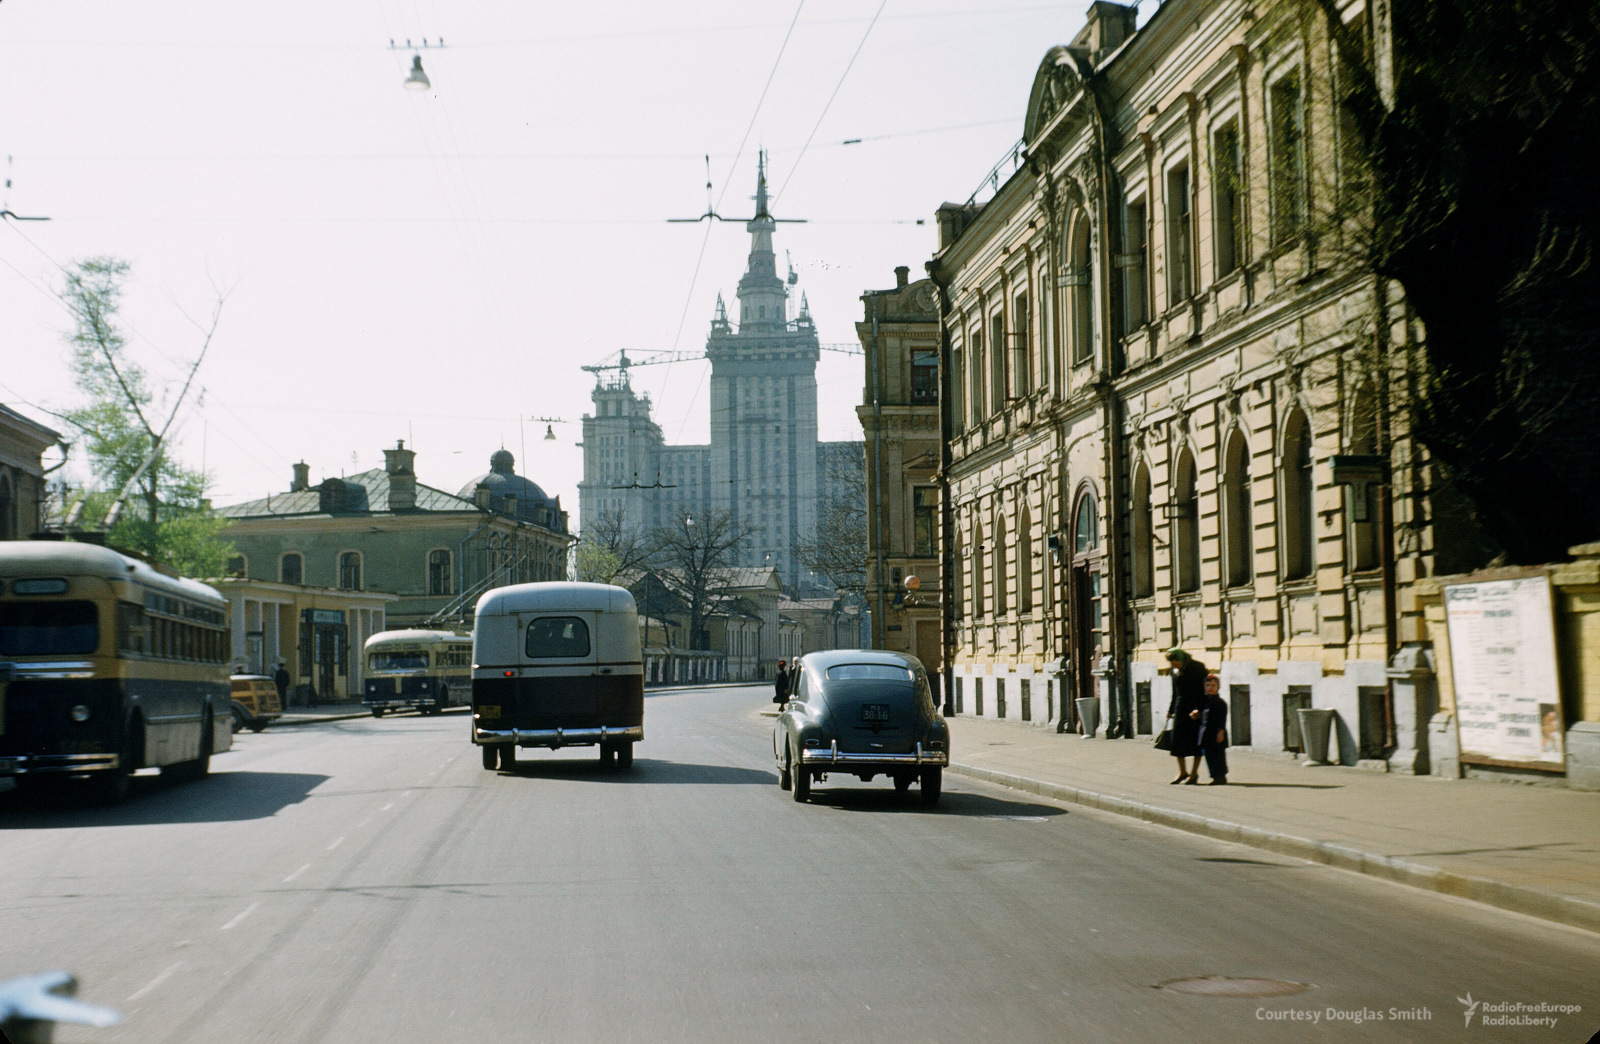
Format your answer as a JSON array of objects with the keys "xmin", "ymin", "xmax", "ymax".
[{"xmin": 0, "ymin": 772, "xmax": 328, "ymax": 831}]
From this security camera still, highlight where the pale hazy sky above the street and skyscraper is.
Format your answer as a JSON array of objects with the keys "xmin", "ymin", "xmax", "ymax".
[{"xmin": 0, "ymin": 0, "xmax": 1126, "ymax": 519}]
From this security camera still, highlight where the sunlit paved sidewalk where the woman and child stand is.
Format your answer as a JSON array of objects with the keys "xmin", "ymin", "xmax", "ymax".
[{"xmin": 950, "ymin": 716, "xmax": 1600, "ymax": 932}]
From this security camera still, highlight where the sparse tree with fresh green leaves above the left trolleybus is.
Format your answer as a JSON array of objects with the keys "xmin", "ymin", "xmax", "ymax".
[{"xmin": 61, "ymin": 258, "xmax": 234, "ymax": 576}]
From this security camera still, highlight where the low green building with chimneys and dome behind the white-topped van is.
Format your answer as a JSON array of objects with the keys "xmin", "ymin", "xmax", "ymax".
[{"xmin": 222, "ymin": 442, "xmax": 573, "ymax": 628}]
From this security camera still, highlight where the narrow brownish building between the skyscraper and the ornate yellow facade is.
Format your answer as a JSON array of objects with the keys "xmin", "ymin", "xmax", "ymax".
[{"xmin": 856, "ymin": 267, "xmax": 944, "ymax": 674}]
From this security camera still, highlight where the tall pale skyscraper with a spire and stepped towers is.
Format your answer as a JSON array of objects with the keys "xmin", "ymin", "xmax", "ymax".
[{"xmin": 579, "ymin": 159, "xmax": 861, "ymax": 591}]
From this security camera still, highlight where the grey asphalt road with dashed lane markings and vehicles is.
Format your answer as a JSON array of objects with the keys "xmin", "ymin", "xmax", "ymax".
[{"xmin": 0, "ymin": 689, "xmax": 1600, "ymax": 1044}]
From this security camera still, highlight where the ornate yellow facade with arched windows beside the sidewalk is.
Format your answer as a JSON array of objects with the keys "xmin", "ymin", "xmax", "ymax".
[{"xmin": 930, "ymin": 0, "xmax": 1470, "ymax": 770}]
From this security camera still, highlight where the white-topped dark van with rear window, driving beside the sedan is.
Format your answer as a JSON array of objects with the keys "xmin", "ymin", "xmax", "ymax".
[{"xmin": 472, "ymin": 583, "xmax": 645, "ymax": 769}]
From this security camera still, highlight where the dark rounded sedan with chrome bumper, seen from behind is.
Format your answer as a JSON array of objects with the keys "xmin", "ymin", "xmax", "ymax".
[{"xmin": 773, "ymin": 648, "xmax": 950, "ymax": 805}]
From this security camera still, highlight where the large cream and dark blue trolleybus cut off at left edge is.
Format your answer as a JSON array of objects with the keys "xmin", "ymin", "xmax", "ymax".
[{"xmin": 0, "ymin": 541, "xmax": 234, "ymax": 801}]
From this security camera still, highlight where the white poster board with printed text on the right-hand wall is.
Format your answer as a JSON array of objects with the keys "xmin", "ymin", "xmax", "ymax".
[{"xmin": 1445, "ymin": 576, "xmax": 1566, "ymax": 772}]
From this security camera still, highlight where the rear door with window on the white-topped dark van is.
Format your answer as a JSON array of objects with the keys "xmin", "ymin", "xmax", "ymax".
[{"xmin": 517, "ymin": 610, "xmax": 602, "ymax": 729}]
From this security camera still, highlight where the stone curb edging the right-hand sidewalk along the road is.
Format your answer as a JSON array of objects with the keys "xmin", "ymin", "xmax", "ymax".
[{"xmin": 950, "ymin": 762, "xmax": 1600, "ymax": 932}]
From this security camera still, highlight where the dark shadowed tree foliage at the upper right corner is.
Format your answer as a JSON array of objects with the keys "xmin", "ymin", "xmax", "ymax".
[{"xmin": 1302, "ymin": 0, "xmax": 1600, "ymax": 562}]
